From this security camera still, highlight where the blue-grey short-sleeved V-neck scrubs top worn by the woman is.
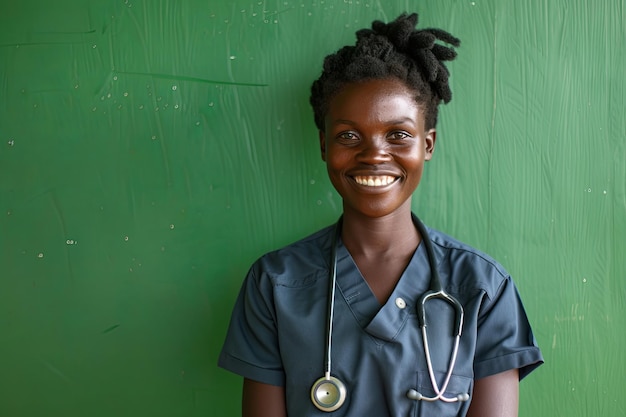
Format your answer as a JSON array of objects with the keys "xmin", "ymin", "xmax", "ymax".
[{"xmin": 218, "ymin": 219, "xmax": 543, "ymax": 417}]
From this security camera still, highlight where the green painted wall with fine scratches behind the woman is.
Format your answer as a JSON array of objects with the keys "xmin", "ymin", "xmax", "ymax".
[{"xmin": 0, "ymin": 0, "xmax": 626, "ymax": 417}]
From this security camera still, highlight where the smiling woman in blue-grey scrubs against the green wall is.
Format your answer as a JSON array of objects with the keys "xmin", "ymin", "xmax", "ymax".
[{"xmin": 219, "ymin": 14, "xmax": 543, "ymax": 417}]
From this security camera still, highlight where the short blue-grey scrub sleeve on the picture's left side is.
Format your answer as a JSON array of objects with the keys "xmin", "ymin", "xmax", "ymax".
[{"xmin": 218, "ymin": 262, "xmax": 285, "ymax": 385}]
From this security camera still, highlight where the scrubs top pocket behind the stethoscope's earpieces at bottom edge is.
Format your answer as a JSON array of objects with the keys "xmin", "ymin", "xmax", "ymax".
[{"xmin": 417, "ymin": 371, "xmax": 473, "ymax": 417}]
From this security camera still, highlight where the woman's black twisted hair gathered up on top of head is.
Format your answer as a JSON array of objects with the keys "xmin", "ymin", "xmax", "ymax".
[{"xmin": 310, "ymin": 13, "xmax": 461, "ymax": 130}]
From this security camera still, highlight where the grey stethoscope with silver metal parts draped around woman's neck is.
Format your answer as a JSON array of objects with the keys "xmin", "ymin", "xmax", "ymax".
[{"xmin": 311, "ymin": 214, "xmax": 469, "ymax": 412}]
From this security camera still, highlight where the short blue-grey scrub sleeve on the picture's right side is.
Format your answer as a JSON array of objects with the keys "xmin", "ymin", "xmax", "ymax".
[{"xmin": 474, "ymin": 277, "xmax": 543, "ymax": 380}]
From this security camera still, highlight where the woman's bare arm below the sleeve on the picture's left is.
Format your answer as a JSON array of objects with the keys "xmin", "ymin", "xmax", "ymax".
[{"xmin": 241, "ymin": 378, "xmax": 287, "ymax": 417}]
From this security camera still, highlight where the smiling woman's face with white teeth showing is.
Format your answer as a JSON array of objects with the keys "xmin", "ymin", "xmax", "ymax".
[{"xmin": 320, "ymin": 78, "xmax": 436, "ymax": 217}]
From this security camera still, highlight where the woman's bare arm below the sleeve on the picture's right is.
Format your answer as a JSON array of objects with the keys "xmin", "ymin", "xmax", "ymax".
[{"xmin": 467, "ymin": 369, "xmax": 519, "ymax": 417}]
